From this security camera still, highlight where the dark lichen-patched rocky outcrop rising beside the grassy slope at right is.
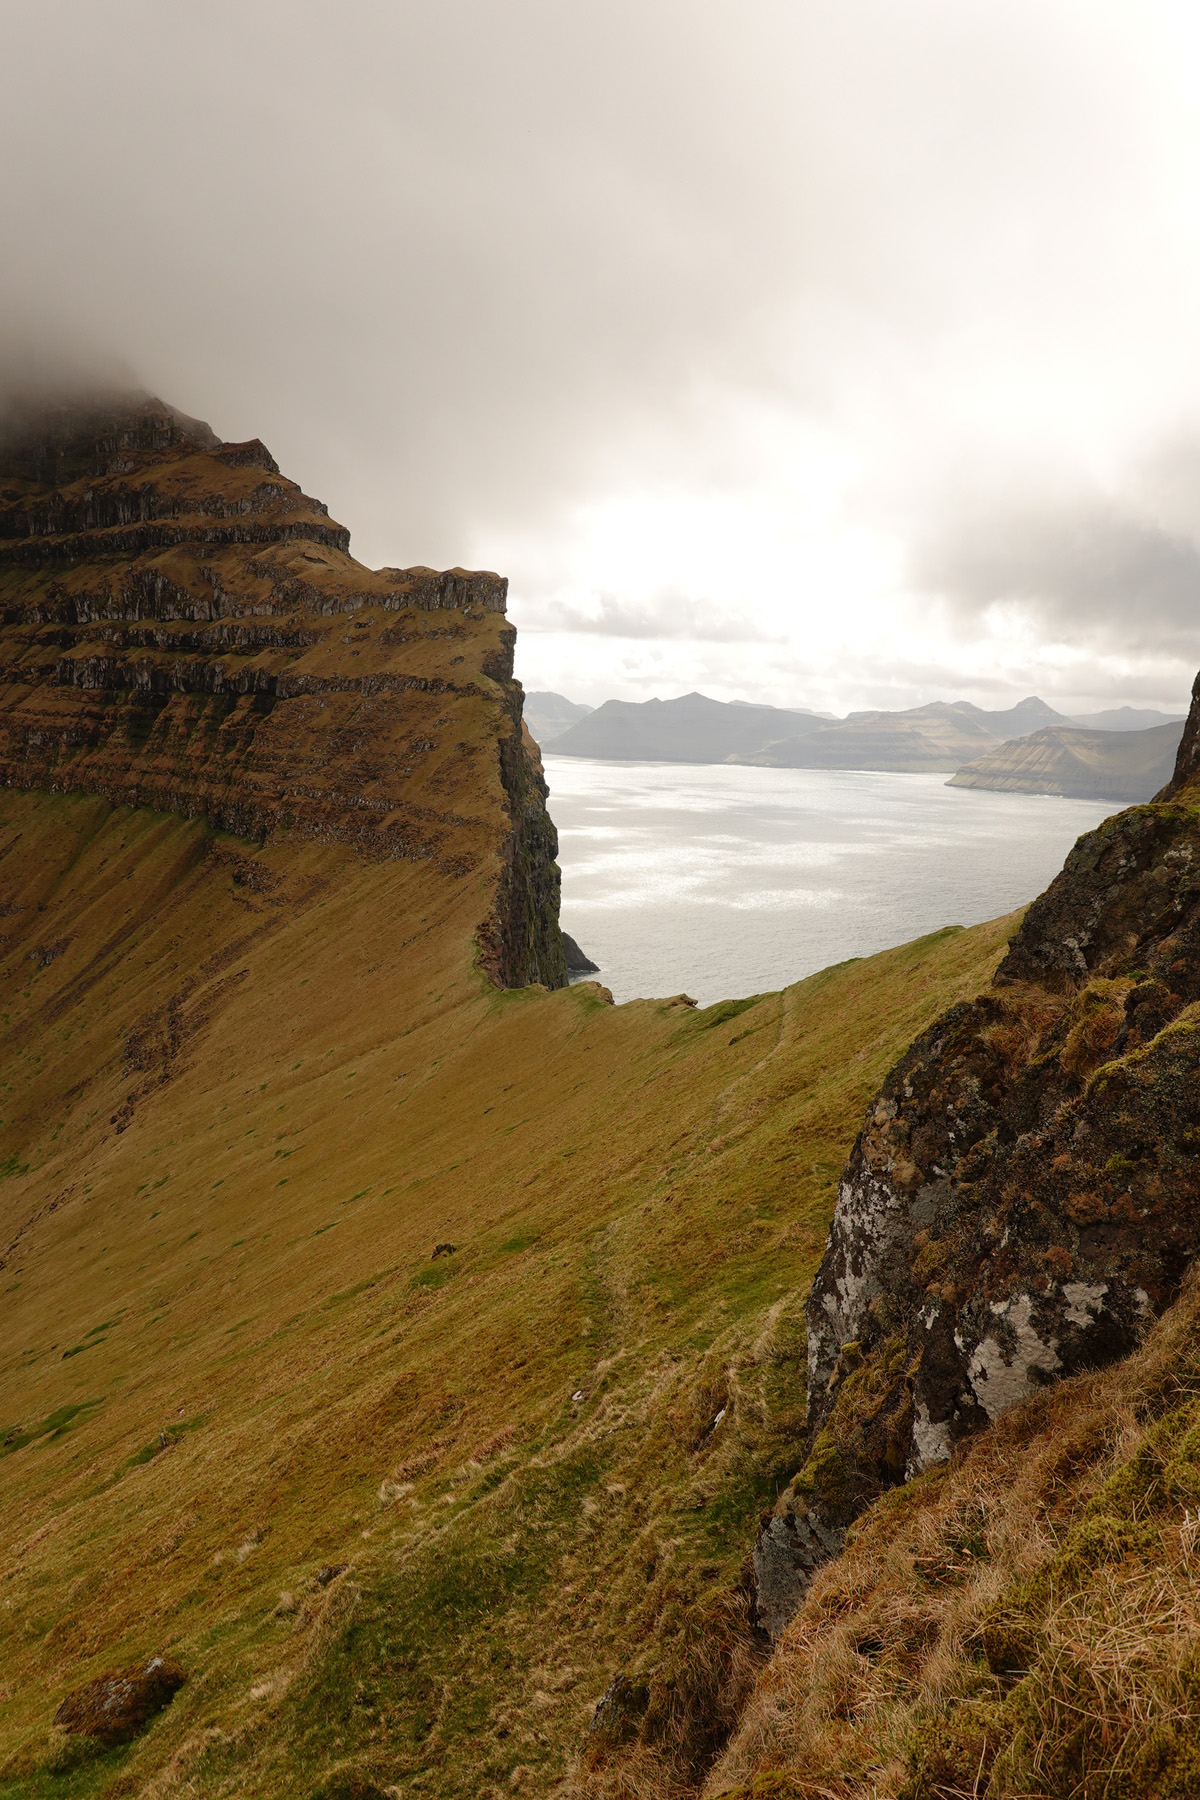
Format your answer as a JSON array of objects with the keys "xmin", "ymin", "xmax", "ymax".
[{"xmin": 759, "ymin": 676, "xmax": 1200, "ymax": 1634}]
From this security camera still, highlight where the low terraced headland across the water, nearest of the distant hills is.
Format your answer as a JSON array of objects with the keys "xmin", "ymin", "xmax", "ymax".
[{"xmin": 948, "ymin": 724, "xmax": 1184, "ymax": 803}]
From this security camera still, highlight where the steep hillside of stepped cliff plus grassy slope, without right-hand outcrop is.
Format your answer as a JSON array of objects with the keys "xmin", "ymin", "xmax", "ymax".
[{"xmin": 0, "ymin": 401, "xmax": 1011, "ymax": 1800}]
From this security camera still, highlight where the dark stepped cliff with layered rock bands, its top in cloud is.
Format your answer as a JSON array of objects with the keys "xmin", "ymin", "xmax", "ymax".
[{"xmin": 0, "ymin": 400, "xmax": 567, "ymax": 986}]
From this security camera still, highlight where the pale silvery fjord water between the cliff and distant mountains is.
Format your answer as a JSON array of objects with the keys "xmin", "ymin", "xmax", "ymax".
[{"xmin": 545, "ymin": 752, "xmax": 1117, "ymax": 1006}]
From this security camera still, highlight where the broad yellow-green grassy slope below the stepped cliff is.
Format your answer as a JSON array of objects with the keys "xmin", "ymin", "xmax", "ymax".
[{"xmin": 0, "ymin": 794, "xmax": 1011, "ymax": 1800}]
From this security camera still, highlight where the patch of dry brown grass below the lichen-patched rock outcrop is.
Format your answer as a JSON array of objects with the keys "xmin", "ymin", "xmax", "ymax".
[{"xmin": 705, "ymin": 1282, "xmax": 1200, "ymax": 1800}]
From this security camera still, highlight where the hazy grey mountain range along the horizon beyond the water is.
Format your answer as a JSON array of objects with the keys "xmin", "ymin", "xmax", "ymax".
[{"xmin": 525, "ymin": 693, "xmax": 1182, "ymax": 801}]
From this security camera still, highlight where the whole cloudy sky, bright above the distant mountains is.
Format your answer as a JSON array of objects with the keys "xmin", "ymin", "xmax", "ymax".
[{"xmin": 0, "ymin": 0, "xmax": 1200, "ymax": 713}]
